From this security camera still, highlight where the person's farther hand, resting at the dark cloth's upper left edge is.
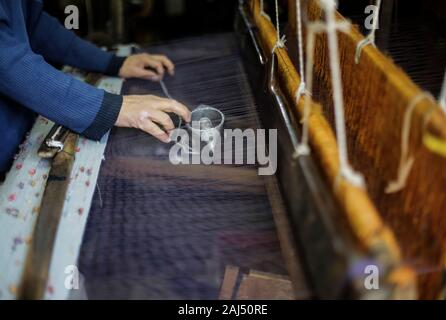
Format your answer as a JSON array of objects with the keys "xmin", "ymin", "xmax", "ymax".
[{"xmin": 119, "ymin": 53, "xmax": 175, "ymax": 81}]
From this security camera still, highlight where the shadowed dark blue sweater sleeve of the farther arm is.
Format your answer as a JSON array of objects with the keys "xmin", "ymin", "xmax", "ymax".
[{"xmin": 30, "ymin": 10, "xmax": 125, "ymax": 76}]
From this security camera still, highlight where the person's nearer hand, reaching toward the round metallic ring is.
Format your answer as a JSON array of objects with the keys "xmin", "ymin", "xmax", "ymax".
[{"xmin": 116, "ymin": 95, "xmax": 191, "ymax": 143}]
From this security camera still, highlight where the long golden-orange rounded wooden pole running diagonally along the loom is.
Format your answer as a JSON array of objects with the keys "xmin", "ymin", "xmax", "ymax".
[{"xmin": 249, "ymin": 0, "xmax": 415, "ymax": 297}]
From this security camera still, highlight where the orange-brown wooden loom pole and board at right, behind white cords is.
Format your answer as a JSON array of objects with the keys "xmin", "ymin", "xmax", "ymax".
[{"xmin": 244, "ymin": 0, "xmax": 446, "ymax": 298}]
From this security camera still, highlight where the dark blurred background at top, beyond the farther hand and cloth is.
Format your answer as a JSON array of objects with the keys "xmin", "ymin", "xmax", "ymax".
[{"xmin": 45, "ymin": 0, "xmax": 238, "ymax": 46}]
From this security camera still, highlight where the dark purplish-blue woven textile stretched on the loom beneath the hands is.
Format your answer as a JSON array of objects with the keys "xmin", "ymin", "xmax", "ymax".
[{"xmin": 79, "ymin": 34, "xmax": 285, "ymax": 299}]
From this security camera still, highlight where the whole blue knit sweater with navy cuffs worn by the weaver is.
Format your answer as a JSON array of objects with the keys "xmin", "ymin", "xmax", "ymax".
[{"xmin": 0, "ymin": 0, "xmax": 123, "ymax": 173}]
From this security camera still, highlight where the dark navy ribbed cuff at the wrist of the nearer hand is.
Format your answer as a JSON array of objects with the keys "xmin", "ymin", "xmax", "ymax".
[{"xmin": 82, "ymin": 92, "xmax": 123, "ymax": 141}]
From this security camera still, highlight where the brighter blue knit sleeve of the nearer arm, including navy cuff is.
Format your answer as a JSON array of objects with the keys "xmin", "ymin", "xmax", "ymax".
[{"xmin": 0, "ymin": 13, "xmax": 122, "ymax": 140}]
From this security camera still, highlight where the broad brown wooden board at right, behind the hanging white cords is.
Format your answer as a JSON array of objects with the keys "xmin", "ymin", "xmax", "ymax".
[{"xmin": 288, "ymin": 0, "xmax": 446, "ymax": 298}]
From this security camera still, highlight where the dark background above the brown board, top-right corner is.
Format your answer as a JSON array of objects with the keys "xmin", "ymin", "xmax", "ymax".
[{"xmin": 339, "ymin": 0, "xmax": 446, "ymax": 96}]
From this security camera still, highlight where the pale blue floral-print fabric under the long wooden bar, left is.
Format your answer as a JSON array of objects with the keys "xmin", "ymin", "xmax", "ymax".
[{"xmin": 0, "ymin": 78, "xmax": 122, "ymax": 299}]
